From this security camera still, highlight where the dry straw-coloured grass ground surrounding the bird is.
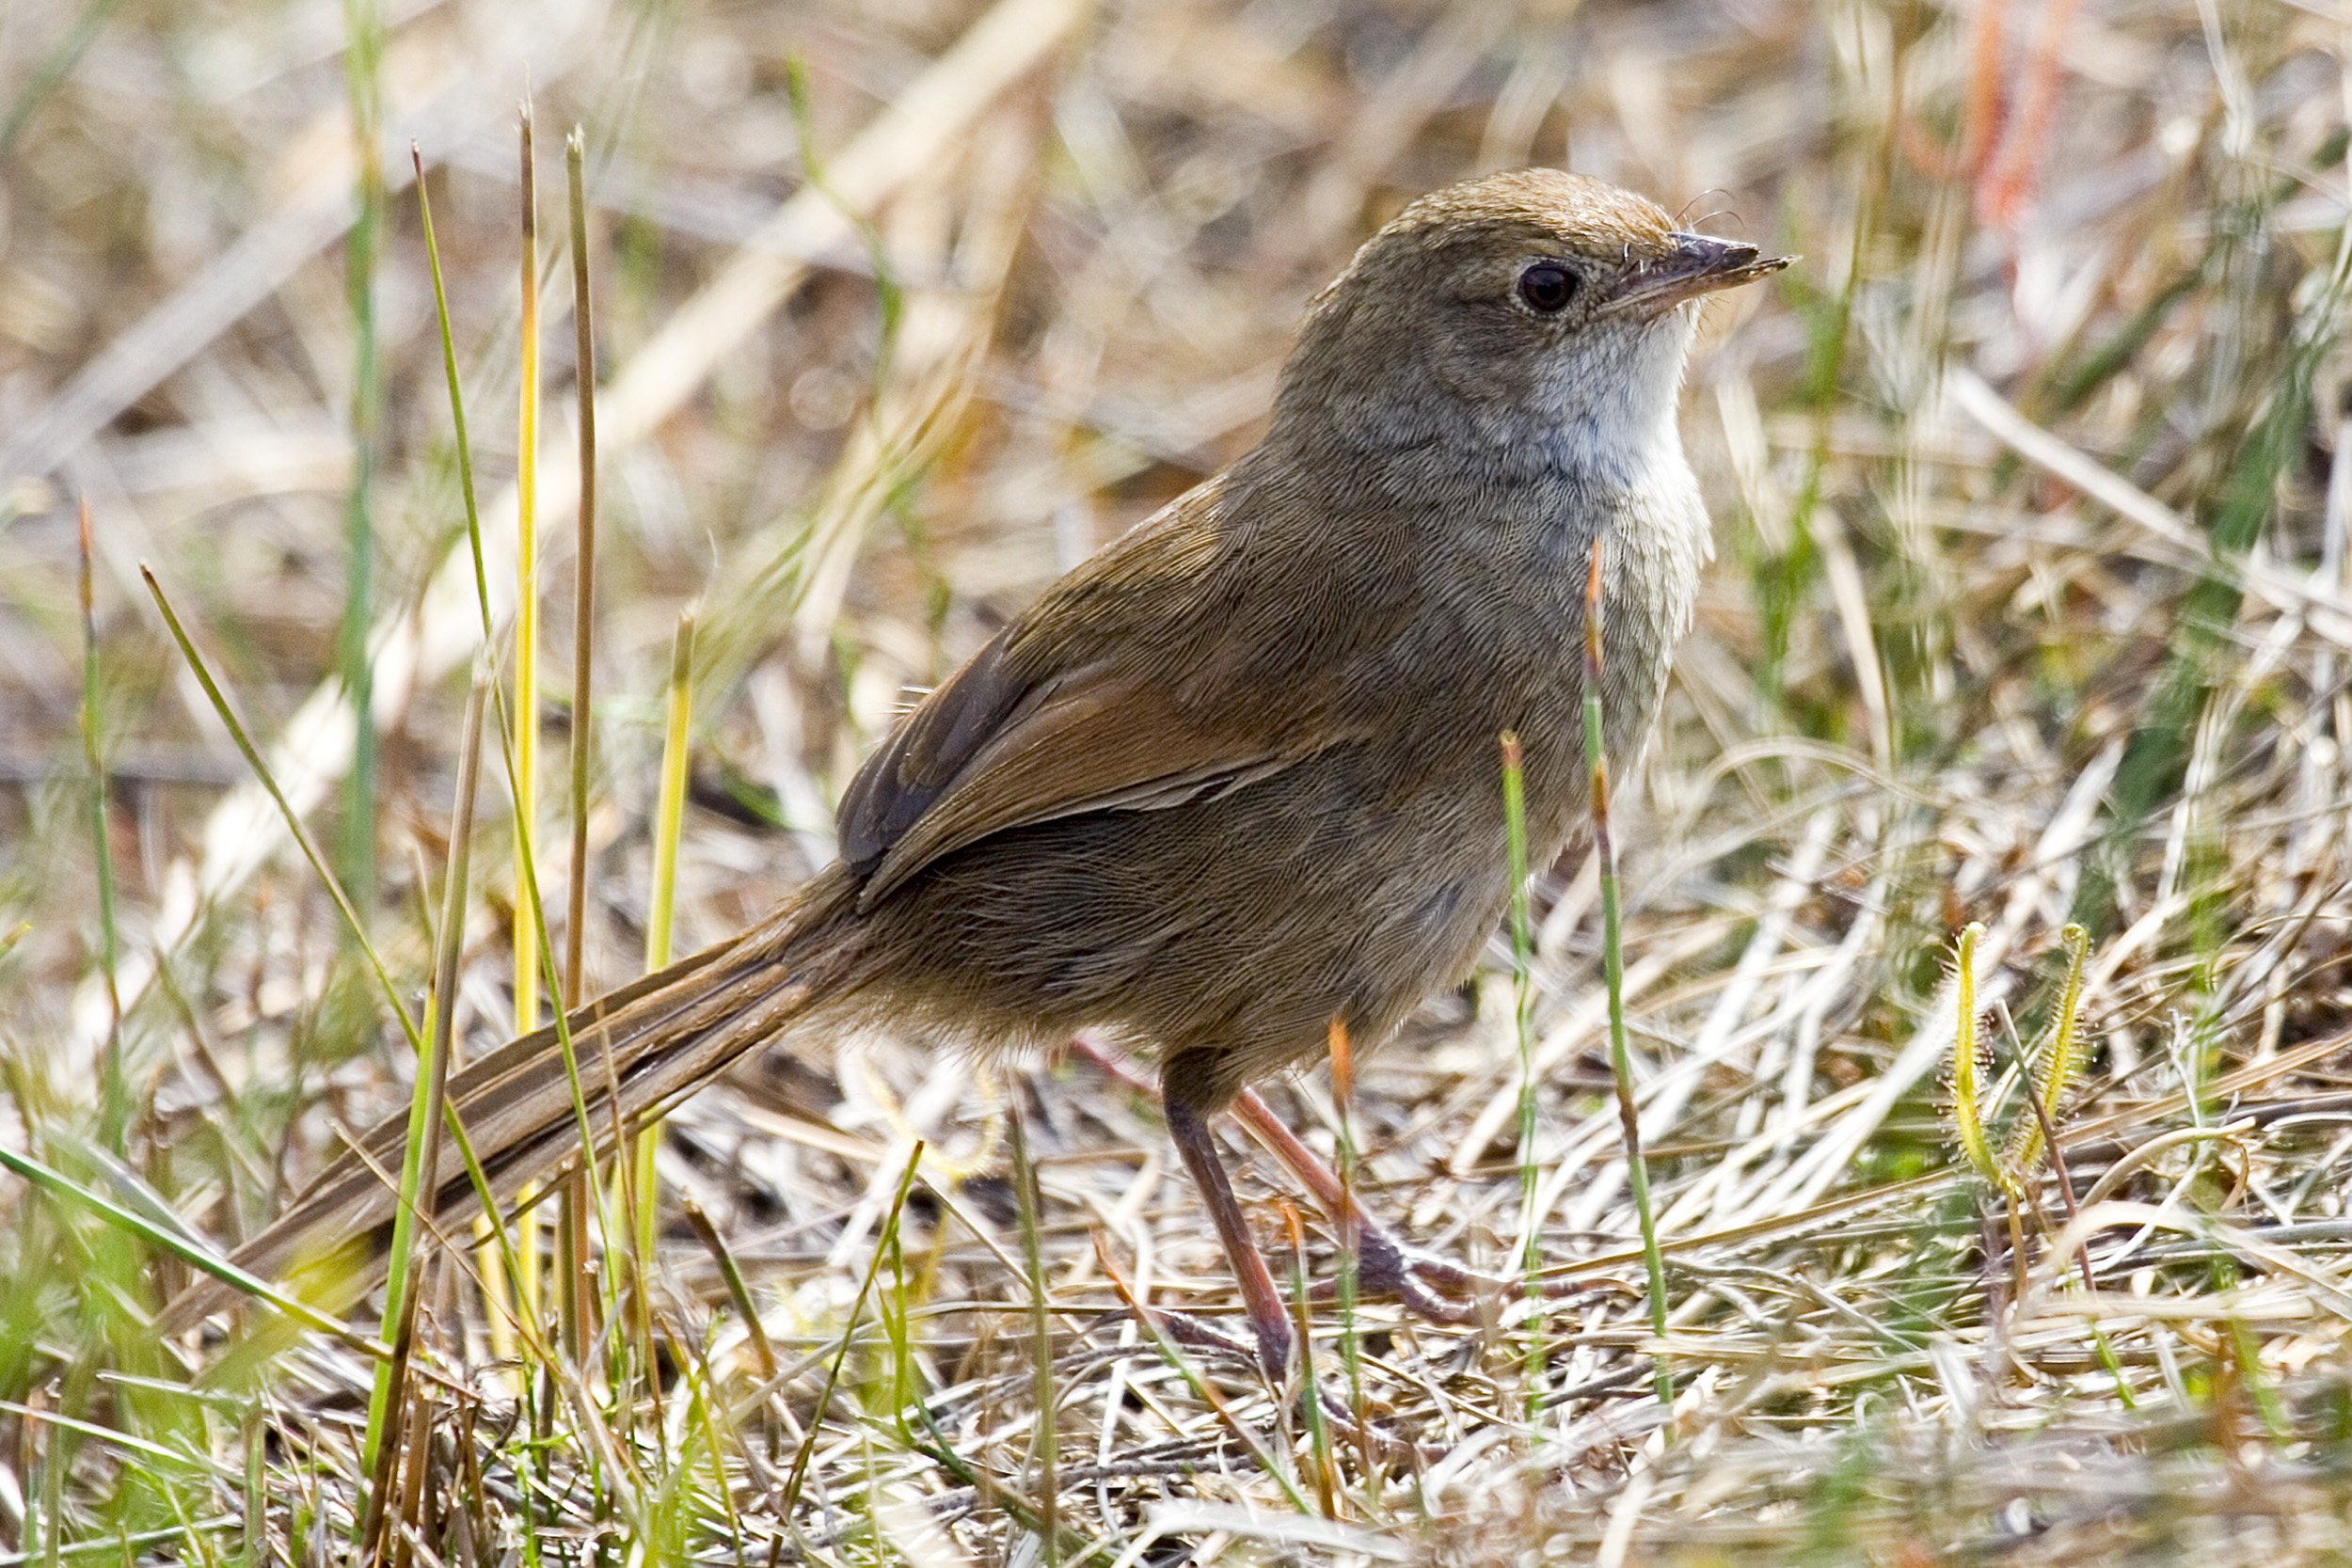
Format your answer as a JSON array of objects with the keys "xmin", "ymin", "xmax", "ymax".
[{"xmin": 0, "ymin": 0, "xmax": 2352, "ymax": 1563}]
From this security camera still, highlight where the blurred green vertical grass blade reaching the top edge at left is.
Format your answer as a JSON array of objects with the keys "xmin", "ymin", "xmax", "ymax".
[{"xmin": 337, "ymin": 0, "xmax": 386, "ymax": 926}]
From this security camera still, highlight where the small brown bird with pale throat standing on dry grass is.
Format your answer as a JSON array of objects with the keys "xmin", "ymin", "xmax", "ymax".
[{"xmin": 167, "ymin": 169, "xmax": 1788, "ymax": 1370}]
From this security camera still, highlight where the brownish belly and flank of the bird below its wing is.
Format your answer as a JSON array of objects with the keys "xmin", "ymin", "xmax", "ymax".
[{"xmin": 847, "ymin": 748, "xmax": 1508, "ymax": 1100}]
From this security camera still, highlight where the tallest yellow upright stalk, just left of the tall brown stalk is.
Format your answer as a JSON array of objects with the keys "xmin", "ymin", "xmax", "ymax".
[{"xmin": 506, "ymin": 99, "xmax": 548, "ymax": 1356}]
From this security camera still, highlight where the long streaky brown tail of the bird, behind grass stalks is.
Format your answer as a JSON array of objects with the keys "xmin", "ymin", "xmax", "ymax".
[{"xmin": 158, "ymin": 889, "xmax": 835, "ymax": 1333}]
